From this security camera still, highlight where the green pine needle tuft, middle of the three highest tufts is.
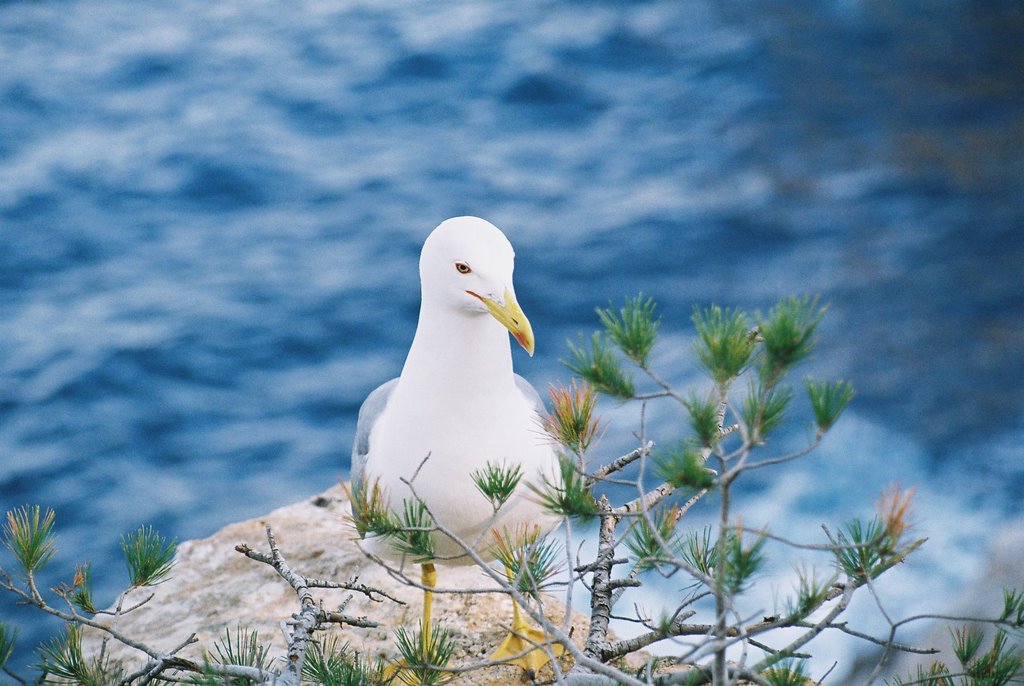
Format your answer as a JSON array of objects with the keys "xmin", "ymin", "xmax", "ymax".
[{"xmin": 691, "ymin": 305, "xmax": 757, "ymax": 387}]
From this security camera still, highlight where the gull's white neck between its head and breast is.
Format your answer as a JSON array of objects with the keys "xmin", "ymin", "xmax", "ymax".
[{"xmin": 399, "ymin": 302, "xmax": 515, "ymax": 400}]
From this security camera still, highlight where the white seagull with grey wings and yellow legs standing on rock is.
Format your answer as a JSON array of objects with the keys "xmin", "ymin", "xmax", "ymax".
[{"xmin": 351, "ymin": 217, "xmax": 564, "ymax": 673}]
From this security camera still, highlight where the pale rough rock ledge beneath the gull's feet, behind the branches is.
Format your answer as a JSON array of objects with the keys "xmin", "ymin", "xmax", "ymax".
[{"xmin": 85, "ymin": 487, "xmax": 587, "ymax": 686}]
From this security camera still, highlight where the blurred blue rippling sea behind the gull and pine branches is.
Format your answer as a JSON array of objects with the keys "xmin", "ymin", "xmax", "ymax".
[{"xmin": 0, "ymin": 0, "xmax": 1024, "ymax": 683}]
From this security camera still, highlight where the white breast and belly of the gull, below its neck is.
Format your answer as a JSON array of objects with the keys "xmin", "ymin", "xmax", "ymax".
[{"xmin": 366, "ymin": 382, "xmax": 556, "ymax": 564}]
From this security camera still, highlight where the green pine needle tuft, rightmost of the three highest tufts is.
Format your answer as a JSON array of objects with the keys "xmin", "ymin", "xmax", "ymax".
[{"xmin": 758, "ymin": 296, "xmax": 825, "ymax": 387}]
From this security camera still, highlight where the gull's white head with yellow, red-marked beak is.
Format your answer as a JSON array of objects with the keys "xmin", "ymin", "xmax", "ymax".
[{"xmin": 420, "ymin": 217, "xmax": 534, "ymax": 355}]
